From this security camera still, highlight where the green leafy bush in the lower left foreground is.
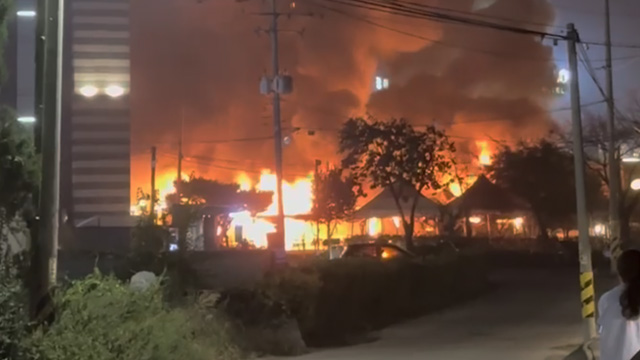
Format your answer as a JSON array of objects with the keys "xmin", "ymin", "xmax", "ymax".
[{"xmin": 26, "ymin": 273, "xmax": 239, "ymax": 360}]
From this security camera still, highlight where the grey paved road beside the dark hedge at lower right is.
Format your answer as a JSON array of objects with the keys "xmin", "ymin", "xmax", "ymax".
[{"xmin": 264, "ymin": 269, "xmax": 613, "ymax": 360}]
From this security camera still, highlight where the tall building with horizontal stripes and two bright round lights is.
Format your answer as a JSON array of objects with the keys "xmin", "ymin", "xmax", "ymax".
[{"xmin": 61, "ymin": 0, "xmax": 131, "ymax": 227}]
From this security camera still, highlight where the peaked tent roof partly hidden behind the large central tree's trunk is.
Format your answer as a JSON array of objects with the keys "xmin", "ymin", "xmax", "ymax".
[{"xmin": 354, "ymin": 184, "xmax": 440, "ymax": 219}]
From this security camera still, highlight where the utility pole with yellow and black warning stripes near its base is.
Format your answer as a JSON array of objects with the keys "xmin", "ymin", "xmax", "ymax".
[{"xmin": 567, "ymin": 24, "xmax": 596, "ymax": 343}]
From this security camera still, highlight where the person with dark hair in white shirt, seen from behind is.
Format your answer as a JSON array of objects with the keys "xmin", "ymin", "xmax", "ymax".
[{"xmin": 598, "ymin": 250, "xmax": 640, "ymax": 360}]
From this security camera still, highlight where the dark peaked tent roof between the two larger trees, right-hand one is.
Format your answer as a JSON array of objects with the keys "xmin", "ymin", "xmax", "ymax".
[{"xmin": 448, "ymin": 175, "xmax": 531, "ymax": 213}]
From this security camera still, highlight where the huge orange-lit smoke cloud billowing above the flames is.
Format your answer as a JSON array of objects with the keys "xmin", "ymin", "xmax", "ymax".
[{"xmin": 131, "ymin": 0, "xmax": 555, "ymax": 193}]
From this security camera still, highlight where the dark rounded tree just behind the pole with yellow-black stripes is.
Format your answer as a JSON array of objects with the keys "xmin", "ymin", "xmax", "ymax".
[{"xmin": 488, "ymin": 140, "xmax": 603, "ymax": 236}]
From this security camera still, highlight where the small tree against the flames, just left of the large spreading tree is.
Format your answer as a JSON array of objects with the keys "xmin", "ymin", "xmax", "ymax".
[{"xmin": 311, "ymin": 168, "xmax": 362, "ymax": 246}]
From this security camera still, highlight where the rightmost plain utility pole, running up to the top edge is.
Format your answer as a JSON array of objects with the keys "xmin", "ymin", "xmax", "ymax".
[{"xmin": 604, "ymin": 0, "xmax": 622, "ymax": 273}]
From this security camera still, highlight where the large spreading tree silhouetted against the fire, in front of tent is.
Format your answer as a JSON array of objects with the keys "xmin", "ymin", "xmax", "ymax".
[{"xmin": 340, "ymin": 117, "xmax": 455, "ymax": 249}]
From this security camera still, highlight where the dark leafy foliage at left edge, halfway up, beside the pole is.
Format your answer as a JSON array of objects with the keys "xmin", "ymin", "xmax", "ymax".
[{"xmin": 0, "ymin": 107, "xmax": 39, "ymax": 219}]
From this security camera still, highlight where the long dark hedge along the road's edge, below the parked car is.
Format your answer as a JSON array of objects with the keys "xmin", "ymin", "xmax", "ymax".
[{"xmin": 254, "ymin": 257, "xmax": 487, "ymax": 346}]
